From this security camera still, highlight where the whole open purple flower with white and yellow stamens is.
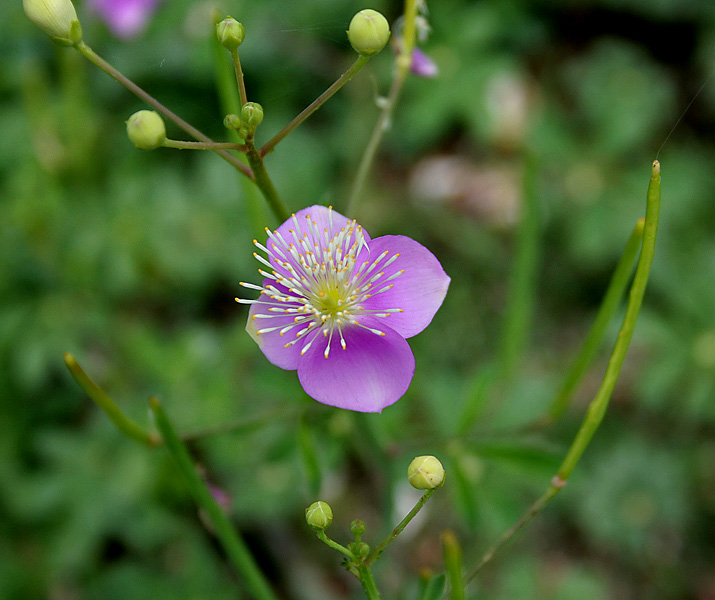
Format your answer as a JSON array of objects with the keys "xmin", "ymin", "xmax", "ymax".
[{"xmin": 237, "ymin": 206, "xmax": 450, "ymax": 412}]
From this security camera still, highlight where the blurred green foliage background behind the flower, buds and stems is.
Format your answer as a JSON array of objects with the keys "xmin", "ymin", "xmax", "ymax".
[{"xmin": 0, "ymin": 0, "xmax": 715, "ymax": 600}]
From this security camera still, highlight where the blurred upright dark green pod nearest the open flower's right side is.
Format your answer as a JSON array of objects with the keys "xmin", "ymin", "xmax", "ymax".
[{"xmin": 498, "ymin": 154, "xmax": 539, "ymax": 381}]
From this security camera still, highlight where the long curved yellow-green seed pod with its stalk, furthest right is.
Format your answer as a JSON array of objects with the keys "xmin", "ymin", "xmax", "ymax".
[{"xmin": 464, "ymin": 160, "xmax": 660, "ymax": 584}]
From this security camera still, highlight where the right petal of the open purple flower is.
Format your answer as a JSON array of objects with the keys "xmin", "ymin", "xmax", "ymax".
[{"xmin": 362, "ymin": 235, "xmax": 450, "ymax": 338}]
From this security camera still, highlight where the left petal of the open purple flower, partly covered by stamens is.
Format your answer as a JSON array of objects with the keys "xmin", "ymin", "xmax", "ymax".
[{"xmin": 246, "ymin": 279, "xmax": 314, "ymax": 370}]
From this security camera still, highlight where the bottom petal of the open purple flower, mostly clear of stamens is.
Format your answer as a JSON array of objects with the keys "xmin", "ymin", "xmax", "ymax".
[{"xmin": 298, "ymin": 317, "xmax": 415, "ymax": 412}]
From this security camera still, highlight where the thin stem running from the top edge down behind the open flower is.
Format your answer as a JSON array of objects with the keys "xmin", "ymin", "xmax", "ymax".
[{"xmin": 345, "ymin": 0, "xmax": 417, "ymax": 215}]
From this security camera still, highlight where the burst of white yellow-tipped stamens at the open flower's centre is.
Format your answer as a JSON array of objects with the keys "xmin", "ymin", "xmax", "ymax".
[{"xmin": 236, "ymin": 207, "xmax": 404, "ymax": 358}]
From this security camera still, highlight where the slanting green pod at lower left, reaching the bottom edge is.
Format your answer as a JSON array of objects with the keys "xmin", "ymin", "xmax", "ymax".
[{"xmin": 149, "ymin": 398, "xmax": 278, "ymax": 600}]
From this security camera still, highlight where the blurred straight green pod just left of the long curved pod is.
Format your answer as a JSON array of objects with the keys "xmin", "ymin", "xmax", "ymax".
[{"xmin": 546, "ymin": 218, "xmax": 645, "ymax": 424}]
